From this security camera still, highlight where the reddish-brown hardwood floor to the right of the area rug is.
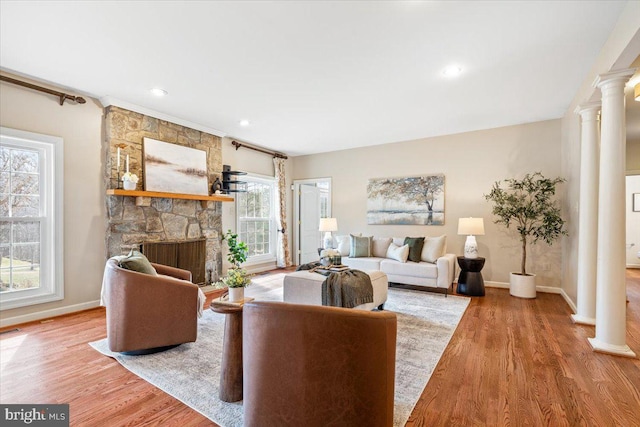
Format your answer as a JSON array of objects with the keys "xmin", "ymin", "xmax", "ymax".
[{"xmin": 407, "ymin": 270, "xmax": 640, "ymax": 427}]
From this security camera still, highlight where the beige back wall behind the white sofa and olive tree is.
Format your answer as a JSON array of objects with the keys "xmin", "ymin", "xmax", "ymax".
[{"xmin": 293, "ymin": 120, "xmax": 561, "ymax": 287}]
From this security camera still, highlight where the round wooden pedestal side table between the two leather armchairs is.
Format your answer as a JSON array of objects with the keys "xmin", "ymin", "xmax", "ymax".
[{"xmin": 211, "ymin": 298, "xmax": 253, "ymax": 402}]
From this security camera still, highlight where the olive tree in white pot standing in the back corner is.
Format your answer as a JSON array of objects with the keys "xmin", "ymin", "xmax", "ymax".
[{"xmin": 484, "ymin": 172, "xmax": 567, "ymax": 298}]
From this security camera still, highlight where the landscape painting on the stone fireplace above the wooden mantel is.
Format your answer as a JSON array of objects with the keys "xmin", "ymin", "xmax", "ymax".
[{"xmin": 143, "ymin": 138, "xmax": 209, "ymax": 196}]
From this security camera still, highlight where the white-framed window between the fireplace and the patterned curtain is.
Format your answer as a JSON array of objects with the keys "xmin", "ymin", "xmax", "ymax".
[{"xmin": 236, "ymin": 178, "xmax": 275, "ymax": 258}]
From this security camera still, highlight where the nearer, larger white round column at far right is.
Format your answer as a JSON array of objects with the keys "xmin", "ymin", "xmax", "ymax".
[{"xmin": 589, "ymin": 69, "xmax": 636, "ymax": 357}]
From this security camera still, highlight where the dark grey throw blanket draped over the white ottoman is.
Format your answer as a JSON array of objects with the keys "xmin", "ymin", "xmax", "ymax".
[{"xmin": 296, "ymin": 262, "xmax": 373, "ymax": 308}]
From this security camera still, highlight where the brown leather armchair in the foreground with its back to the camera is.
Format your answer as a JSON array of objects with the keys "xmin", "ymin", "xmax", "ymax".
[{"xmin": 242, "ymin": 302, "xmax": 397, "ymax": 427}]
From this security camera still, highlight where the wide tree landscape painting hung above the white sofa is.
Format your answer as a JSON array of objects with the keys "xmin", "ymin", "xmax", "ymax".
[{"xmin": 367, "ymin": 175, "xmax": 444, "ymax": 225}]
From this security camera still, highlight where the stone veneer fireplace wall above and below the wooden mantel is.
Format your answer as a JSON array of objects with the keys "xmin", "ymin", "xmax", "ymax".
[{"xmin": 104, "ymin": 106, "xmax": 222, "ymax": 282}]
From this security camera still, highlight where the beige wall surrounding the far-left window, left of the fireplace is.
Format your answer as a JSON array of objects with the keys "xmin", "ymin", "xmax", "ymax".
[{"xmin": 0, "ymin": 77, "xmax": 105, "ymax": 324}]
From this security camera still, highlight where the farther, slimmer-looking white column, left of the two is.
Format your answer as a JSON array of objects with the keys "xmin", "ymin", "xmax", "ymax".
[{"xmin": 571, "ymin": 102, "xmax": 601, "ymax": 325}]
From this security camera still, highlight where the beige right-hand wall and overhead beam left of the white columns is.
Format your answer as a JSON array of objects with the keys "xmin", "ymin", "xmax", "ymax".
[{"xmin": 562, "ymin": 1, "xmax": 640, "ymax": 304}]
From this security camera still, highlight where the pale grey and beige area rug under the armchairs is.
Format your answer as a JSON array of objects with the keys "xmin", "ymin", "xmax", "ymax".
[{"xmin": 90, "ymin": 274, "xmax": 470, "ymax": 427}]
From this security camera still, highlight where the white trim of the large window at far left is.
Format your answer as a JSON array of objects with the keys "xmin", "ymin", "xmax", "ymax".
[{"xmin": 0, "ymin": 127, "xmax": 64, "ymax": 311}]
